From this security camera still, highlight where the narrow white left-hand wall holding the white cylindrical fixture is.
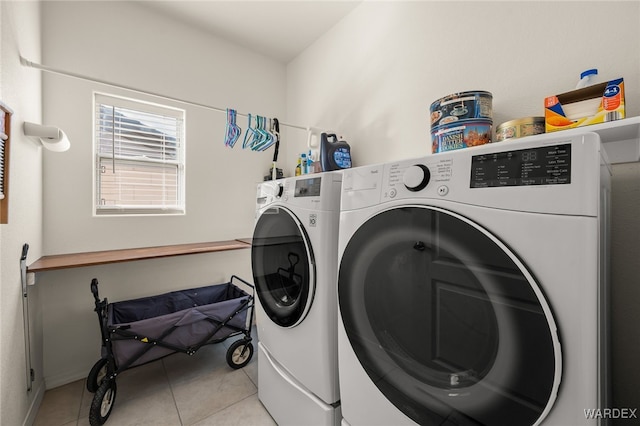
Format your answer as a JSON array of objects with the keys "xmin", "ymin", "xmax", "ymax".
[{"xmin": 0, "ymin": 1, "xmax": 44, "ymax": 425}]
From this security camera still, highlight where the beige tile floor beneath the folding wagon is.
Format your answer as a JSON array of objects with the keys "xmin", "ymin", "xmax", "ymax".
[{"xmin": 34, "ymin": 327, "xmax": 276, "ymax": 426}]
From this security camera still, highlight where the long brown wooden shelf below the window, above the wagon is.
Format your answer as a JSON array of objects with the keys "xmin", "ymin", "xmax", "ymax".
[{"xmin": 27, "ymin": 238, "xmax": 251, "ymax": 272}]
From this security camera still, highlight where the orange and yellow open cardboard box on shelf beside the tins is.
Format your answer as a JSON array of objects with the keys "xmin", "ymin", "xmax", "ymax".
[{"xmin": 544, "ymin": 78, "xmax": 625, "ymax": 132}]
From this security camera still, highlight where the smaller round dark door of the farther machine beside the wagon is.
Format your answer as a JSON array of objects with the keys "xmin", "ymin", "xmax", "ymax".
[{"xmin": 251, "ymin": 207, "xmax": 315, "ymax": 327}]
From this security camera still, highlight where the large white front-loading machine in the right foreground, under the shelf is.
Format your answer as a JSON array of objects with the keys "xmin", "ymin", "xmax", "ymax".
[{"xmin": 338, "ymin": 132, "xmax": 610, "ymax": 426}]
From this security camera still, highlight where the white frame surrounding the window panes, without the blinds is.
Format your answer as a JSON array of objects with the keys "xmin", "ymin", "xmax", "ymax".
[{"xmin": 92, "ymin": 91, "xmax": 186, "ymax": 217}]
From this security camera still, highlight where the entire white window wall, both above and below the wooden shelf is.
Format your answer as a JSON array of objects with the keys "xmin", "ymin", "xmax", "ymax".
[{"xmin": 37, "ymin": 1, "xmax": 285, "ymax": 388}]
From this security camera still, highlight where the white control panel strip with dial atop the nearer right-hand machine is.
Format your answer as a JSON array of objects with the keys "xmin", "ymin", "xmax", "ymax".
[{"xmin": 341, "ymin": 132, "xmax": 606, "ymax": 215}]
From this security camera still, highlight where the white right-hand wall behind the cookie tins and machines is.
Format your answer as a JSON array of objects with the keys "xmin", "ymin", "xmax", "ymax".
[{"xmin": 287, "ymin": 1, "xmax": 640, "ymax": 408}]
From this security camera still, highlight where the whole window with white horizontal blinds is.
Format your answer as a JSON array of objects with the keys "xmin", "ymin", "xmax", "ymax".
[{"xmin": 95, "ymin": 93, "xmax": 185, "ymax": 215}]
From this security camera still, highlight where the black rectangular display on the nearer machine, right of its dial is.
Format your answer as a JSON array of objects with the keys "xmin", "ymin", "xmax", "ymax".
[{"xmin": 470, "ymin": 144, "xmax": 571, "ymax": 188}]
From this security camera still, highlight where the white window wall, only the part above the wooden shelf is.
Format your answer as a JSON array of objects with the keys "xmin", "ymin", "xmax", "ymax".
[{"xmin": 43, "ymin": 1, "xmax": 285, "ymax": 254}]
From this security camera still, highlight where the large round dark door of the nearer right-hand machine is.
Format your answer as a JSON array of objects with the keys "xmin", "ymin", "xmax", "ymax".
[{"xmin": 338, "ymin": 206, "xmax": 561, "ymax": 425}]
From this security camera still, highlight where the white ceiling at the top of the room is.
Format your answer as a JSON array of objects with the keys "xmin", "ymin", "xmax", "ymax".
[{"xmin": 142, "ymin": 0, "xmax": 362, "ymax": 63}]
